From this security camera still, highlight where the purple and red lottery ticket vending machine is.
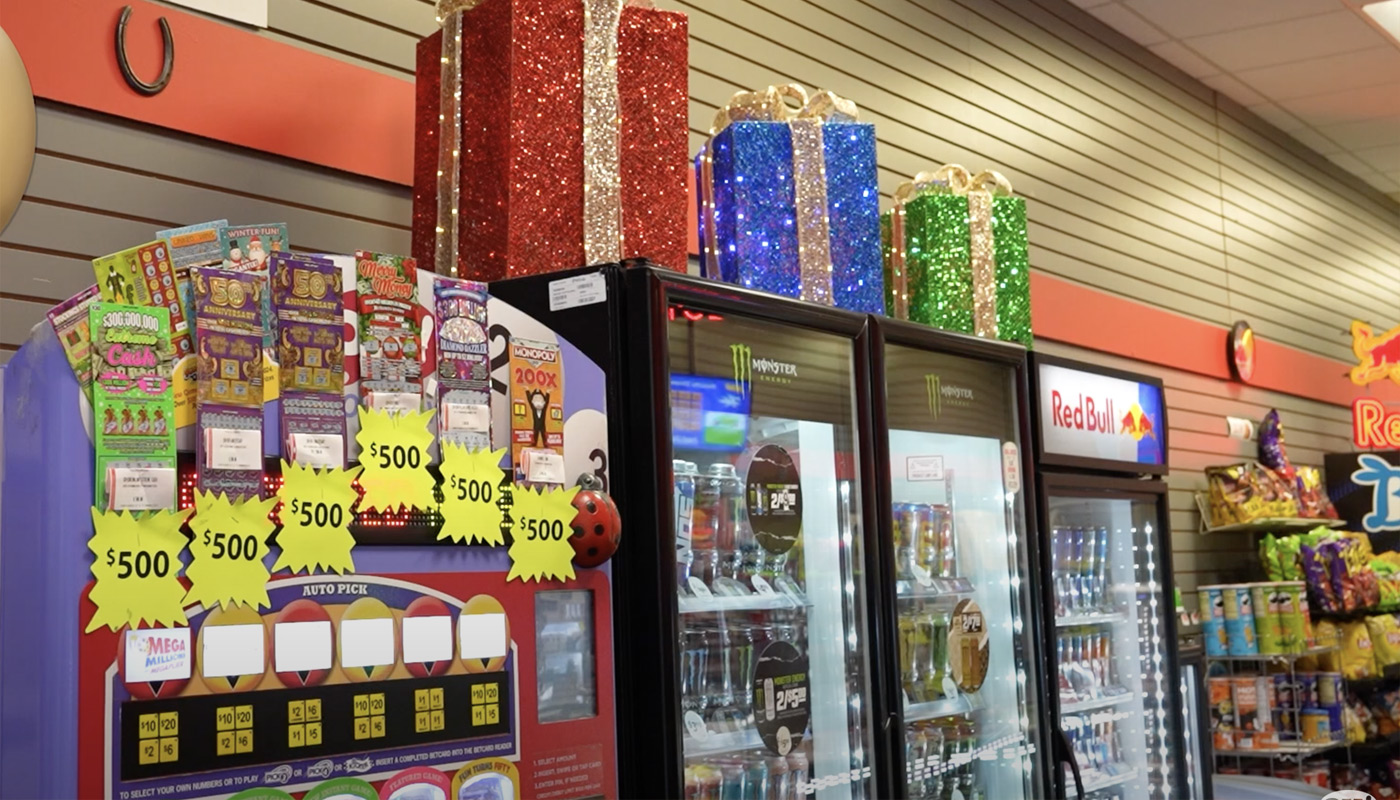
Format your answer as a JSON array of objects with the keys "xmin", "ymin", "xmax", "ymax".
[{"xmin": 0, "ymin": 261, "xmax": 617, "ymax": 800}]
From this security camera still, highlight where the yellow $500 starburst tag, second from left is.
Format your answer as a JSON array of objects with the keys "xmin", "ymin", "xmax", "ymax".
[{"xmin": 185, "ymin": 492, "xmax": 277, "ymax": 609}]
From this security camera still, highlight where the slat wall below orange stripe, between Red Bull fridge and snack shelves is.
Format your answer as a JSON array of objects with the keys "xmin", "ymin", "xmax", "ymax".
[{"xmin": 1036, "ymin": 340, "xmax": 1351, "ymax": 608}]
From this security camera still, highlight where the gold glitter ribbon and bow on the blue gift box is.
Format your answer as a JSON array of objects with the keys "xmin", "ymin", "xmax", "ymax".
[{"xmin": 700, "ymin": 83, "xmax": 860, "ymax": 305}]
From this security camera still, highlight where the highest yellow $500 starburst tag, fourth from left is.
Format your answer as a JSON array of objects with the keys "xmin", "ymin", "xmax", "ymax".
[{"xmin": 354, "ymin": 408, "xmax": 437, "ymax": 511}]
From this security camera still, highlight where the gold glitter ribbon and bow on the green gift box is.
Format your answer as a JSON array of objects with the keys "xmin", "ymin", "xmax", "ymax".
[{"xmin": 889, "ymin": 164, "xmax": 1012, "ymax": 339}]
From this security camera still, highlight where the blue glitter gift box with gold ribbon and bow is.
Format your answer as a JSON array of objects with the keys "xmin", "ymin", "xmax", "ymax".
[{"xmin": 696, "ymin": 85, "xmax": 885, "ymax": 314}]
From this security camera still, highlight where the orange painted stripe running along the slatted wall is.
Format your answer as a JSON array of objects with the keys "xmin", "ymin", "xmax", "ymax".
[{"xmin": 0, "ymin": 0, "xmax": 1400, "ymax": 406}]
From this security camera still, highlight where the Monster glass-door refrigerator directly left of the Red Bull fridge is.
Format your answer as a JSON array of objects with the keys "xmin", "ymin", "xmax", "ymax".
[{"xmin": 874, "ymin": 319, "xmax": 1050, "ymax": 800}]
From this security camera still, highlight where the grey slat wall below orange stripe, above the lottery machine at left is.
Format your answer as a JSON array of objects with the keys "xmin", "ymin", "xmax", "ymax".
[{"xmin": 0, "ymin": 104, "xmax": 412, "ymax": 357}]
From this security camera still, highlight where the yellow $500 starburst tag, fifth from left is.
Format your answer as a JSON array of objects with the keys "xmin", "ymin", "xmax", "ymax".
[{"xmin": 438, "ymin": 443, "xmax": 512, "ymax": 545}]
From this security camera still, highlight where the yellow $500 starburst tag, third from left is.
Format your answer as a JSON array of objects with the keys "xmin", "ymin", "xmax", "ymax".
[{"xmin": 272, "ymin": 461, "xmax": 360, "ymax": 574}]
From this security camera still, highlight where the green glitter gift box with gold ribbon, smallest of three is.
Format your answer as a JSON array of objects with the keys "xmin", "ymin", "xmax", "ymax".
[{"xmin": 881, "ymin": 164, "xmax": 1032, "ymax": 347}]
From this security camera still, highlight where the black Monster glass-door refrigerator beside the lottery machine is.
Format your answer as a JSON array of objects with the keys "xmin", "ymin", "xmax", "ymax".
[{"xmin": 609, "ymin": 268, "xmax": 893, "ymax": 800}]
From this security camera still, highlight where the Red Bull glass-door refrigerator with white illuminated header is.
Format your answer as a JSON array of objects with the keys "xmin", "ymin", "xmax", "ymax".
[{"xmin": 1030, "ymin": 353, "xmax": 1189, "ymax": 800}]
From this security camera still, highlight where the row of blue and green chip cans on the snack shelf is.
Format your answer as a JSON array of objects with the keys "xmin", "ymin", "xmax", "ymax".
[{"xmin": 1200, "ymin": 580, "xmax": 1317, "ymax": 657}]
